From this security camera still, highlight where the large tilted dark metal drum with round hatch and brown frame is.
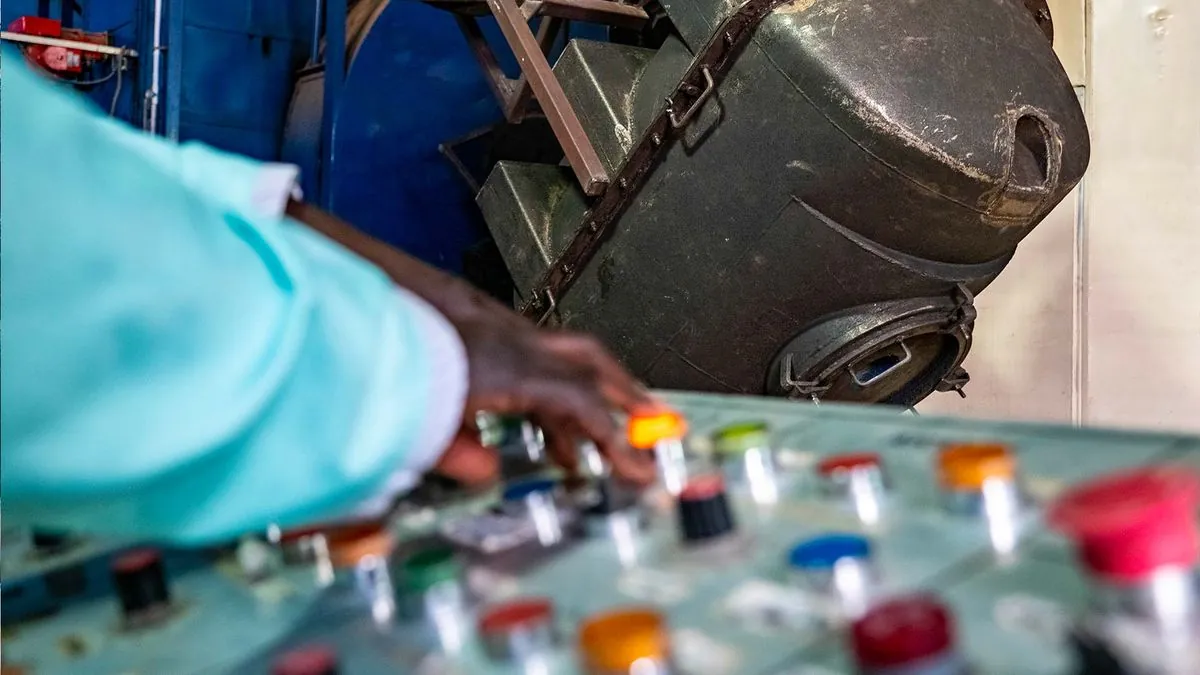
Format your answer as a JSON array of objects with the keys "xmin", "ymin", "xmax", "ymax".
[{"xmin": 439, "ymin": 0, "xmax": 1090, "ymax": 406}]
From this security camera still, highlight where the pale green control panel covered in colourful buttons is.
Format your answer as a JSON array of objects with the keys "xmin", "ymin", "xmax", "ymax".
[{"xmin": 0, "ymin": 394, "xmax": 1200, "ymax": 675}]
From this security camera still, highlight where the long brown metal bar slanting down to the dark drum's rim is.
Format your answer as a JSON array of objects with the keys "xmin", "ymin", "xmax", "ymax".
[{"xmin": 487, "ymin": 0, "xmax": 608, "ymax": 197}]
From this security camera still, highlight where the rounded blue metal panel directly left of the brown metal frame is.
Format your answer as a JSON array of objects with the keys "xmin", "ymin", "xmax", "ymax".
[{"xmin": 326, "ymin": 1, "xmax": 502, "ymax": 271}]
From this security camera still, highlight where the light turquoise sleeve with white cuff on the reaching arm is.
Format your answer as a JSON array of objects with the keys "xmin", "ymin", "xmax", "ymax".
[{"xmin": 0, "ymin": 53, "xmax": 466, "ymax": 542}]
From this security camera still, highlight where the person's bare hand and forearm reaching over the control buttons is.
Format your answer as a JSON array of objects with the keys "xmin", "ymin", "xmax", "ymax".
[{"xmin": 288, "ymin": 201, "xmax": 660, "ymax": 484}]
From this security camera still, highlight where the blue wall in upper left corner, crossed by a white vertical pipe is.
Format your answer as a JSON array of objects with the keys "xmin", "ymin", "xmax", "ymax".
[{"xmin": 0, "ymin": 0, "xmax": 314, "ymax": 160}]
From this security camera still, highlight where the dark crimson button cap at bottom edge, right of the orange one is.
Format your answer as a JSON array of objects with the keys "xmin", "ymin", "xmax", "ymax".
[{"xmin": 851, "ymin": 595, "xmax": 954, "ymax": 668}]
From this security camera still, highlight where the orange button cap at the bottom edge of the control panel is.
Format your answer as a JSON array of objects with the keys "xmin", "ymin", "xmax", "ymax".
[{"xmin": 578, "ymin": 609, "xmax": 670, "ymax": 675}]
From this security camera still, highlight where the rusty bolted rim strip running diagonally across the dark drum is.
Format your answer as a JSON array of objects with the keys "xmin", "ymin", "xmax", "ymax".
[{"xmin": 513, "ymin": 0, "xmax": 786, "ymax": 323}]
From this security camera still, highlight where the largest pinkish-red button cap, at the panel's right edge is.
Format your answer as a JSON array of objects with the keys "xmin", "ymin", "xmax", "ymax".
[{"xmin": 1048, "ymin": 467, "xmax": 1200, "ymax": 583}]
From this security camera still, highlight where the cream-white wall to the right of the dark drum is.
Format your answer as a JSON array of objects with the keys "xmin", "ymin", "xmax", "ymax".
[{"xmin": 920, "ymin": 0, "xmax": 1200, "ymax": 431}]
